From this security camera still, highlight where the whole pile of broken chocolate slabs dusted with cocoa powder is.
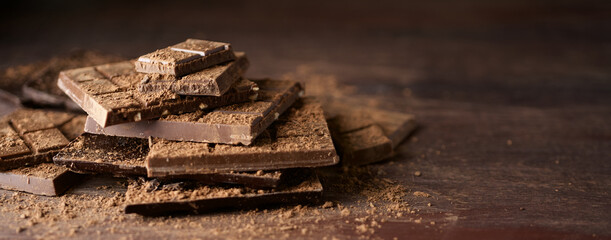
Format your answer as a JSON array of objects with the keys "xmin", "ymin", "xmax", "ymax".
[{"xmin": 0, "ymin": 39, "xmax": 415, "ymax": 215}]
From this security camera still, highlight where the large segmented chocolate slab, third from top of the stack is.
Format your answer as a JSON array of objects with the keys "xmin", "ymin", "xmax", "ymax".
[{"xmin": 58, "ymin": 61, "xmax": 256, "ymax": 127}]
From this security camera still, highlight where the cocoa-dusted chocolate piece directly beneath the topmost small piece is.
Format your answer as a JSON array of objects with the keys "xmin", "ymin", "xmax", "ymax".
[{"xmin": 138, "ymin": 52, "xmax": 249, "ymax": 97}]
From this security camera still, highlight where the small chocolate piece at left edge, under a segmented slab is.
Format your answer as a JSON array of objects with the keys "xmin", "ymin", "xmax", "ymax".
[{"xmin": 0, "ymin": 163, "xmax": 83, "ymax": 196}]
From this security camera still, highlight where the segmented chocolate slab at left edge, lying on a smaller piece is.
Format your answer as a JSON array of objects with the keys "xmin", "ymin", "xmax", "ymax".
[{"xmin": 0, "ymin": 109, "xmax": 85, "ymax": 170}]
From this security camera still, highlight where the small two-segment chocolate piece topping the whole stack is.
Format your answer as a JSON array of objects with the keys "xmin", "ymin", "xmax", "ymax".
[{"xmin": 135, "ymin": 39, "xmax": 235, "ymax": 77}]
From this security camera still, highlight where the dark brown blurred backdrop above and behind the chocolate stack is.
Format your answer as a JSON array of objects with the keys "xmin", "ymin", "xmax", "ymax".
[{"xmin": 0, "ymin": 0, "xmax": 611, "ymax": 106}]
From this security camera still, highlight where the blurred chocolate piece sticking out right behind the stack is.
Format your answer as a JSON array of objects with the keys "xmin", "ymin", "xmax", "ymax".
[{"xmin": 327, "ymin": 104, "xmax": 416, "ymax": 165}]
